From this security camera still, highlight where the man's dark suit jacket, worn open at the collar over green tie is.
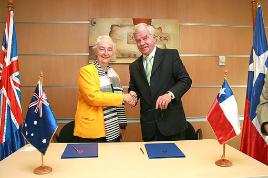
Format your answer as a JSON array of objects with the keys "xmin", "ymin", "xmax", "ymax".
[{"xmin": 128, "ymin": 48, "xmax": 192, "ymax": 140}]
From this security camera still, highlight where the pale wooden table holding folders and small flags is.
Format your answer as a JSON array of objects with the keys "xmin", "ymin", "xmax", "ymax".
[{"xmin": 0, "ymin": 139, "xmax": 268, "ymax": 178}]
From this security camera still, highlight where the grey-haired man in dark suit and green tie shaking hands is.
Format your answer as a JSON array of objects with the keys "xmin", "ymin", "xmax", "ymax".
[{"xmin": 128, "ymin": 23, "xmax": 192, "ymax": 141}]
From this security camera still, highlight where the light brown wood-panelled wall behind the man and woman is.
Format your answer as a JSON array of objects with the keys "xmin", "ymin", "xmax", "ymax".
[{"xmin": 0, "ymin": 0, "xmax": 268, "ymax": 148}]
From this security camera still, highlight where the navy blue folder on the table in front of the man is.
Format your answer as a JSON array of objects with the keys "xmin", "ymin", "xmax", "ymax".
[{"xmin": 145, "ymin": 143, "xmax": 185, "ymax": 159}]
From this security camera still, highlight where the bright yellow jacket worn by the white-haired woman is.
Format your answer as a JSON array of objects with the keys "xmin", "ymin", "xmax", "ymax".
[{"xmin": 74, "ymin": 64, "xmax": 123, "ymax": 138}]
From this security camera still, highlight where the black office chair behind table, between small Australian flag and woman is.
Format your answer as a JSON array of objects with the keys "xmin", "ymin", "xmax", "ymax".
[{"xmin": 57, "ymin": 121, "xmax": 77, "ymax": 143}]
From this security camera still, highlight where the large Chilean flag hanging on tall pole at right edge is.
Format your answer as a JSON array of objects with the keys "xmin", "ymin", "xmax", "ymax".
[{"xmin": 240, "ymin": 5, "xmax": 268, "ymax": 165}]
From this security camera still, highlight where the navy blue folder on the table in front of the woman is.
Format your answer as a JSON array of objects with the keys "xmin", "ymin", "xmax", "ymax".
[{"xmin": 61, "ymin": 143, "xmax": 98, "ymax": 159}]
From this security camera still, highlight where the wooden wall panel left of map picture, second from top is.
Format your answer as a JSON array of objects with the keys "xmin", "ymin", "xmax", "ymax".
[{"xmin": 16, "ymin": 23, "xmax": 88, "ymax": 53}]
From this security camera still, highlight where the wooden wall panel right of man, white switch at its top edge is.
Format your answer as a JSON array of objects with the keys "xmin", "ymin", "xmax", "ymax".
[{"xmin": 182, "ymin": 57, "xmax": 249, "ymax": 86}]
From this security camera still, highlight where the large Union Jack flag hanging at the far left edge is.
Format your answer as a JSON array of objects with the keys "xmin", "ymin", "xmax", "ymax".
[{"xmin": 0, "ymin": 11, "xmax": 25, "ymax": 160}]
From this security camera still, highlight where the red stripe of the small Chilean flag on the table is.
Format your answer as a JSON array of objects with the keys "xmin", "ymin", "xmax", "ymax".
[{"xmin": 208, "ymin": 98, "xmax": 236, "ymax": 144}]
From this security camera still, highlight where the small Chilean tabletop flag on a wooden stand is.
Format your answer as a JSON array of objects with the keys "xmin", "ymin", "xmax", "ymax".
[{"xmin": 207, "ymin": 80, "xmax": 241, "ymax": 144}]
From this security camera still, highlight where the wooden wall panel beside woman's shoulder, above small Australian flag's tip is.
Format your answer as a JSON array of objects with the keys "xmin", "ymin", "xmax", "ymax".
[{"xmin": 19, "ymin": 55, "xmax": 88, "ymax": 86}]
